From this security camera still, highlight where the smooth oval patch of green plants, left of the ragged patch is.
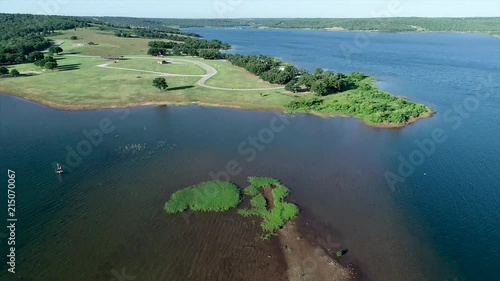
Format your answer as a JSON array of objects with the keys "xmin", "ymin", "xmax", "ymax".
[{"xmin": 165, "ymin": 181, "xmax": 240, "ymax": 214}]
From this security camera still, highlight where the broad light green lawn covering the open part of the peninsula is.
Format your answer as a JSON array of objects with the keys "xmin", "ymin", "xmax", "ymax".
[{"xmin": 0, "ymin": 55, "xmax": 292, "ymax": 109}]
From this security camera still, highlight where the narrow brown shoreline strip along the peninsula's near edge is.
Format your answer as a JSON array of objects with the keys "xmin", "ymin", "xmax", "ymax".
[{"xmin": 0, "ymin": 91, "xmax": 435, "ymax": 129}]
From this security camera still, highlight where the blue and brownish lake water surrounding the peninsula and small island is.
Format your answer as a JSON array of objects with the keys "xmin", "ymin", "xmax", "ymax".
[{"xmin": 0, "ymin": 29, "xmax": 500, "ymax": 280}]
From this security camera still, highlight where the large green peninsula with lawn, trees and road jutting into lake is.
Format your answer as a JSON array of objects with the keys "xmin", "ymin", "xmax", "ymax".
[{"xmin": 0, "ymin": 14, "xmax": 432, "ymax": 127}]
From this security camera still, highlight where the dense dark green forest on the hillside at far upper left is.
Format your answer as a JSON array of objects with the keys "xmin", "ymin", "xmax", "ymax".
[{"xmin": 0, "ymin": 14, "xmax": 88, "ymax": 65}]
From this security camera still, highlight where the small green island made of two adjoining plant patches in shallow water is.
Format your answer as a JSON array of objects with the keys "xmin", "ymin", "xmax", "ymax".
[{"xmin": 165, "ymin": 177, "xmax": 299, "ymax": 239}]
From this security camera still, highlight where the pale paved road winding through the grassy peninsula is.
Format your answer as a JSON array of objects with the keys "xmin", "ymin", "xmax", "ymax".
[{"xmin": 66, "ymin": 55, "xmax": 285, "ymax": 91}]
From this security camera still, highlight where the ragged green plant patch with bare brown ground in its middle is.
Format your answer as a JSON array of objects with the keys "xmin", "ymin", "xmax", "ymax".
[{"xmin": 239, "ymin": 177, "xmax": 299, "ymax": 238}]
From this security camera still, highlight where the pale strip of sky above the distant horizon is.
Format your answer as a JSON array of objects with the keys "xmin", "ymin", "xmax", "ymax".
[{"xmin": 0, "ymin": 0, "xmax": 500, "ymax": 18}]
